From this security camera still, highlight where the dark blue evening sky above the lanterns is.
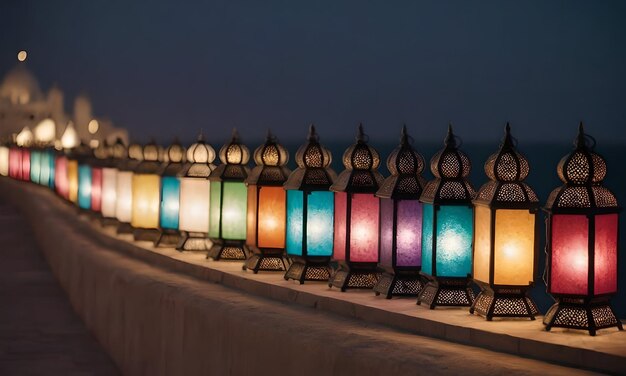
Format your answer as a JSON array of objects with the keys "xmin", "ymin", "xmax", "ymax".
[{"xmin": 0, "ymin": 0, "xmax": 626, "ymax": 145}]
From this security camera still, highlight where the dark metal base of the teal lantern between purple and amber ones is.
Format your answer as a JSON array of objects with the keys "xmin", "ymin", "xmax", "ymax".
[{"xmin": 417, "ymin": 273, "xmax": 474, "ymax": 309}]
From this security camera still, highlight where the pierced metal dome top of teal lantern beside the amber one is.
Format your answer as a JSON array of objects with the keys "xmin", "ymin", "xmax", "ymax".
[{"xmin": 420, "ymin": 125, "xmax": 476, "ymax": 204}]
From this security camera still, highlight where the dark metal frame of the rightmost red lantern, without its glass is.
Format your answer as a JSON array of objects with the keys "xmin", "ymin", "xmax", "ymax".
[{"xmin": 543, "ymin": 123, "xmax": 624, "ymax": 336}]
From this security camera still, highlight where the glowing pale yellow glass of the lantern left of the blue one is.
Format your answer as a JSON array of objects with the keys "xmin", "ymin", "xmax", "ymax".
[{"xmin": 130, "ymin": 174, "xmax": 161, "ymax": 228}]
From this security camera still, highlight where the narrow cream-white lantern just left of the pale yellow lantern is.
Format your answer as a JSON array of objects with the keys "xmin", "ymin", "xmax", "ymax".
[{"xmin": 115, "ymin": 144, "xmax": 143, "ymax": 234}]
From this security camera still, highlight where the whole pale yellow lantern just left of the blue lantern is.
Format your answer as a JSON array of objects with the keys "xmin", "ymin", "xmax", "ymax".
[{"xmin": 130, "ymin": 142, "xmax": 161, "ymax": 242}]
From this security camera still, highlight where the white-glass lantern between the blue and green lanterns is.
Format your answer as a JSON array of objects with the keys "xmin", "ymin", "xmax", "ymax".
[{"xmin": 176, "ymin": 133, "xmax": 215, "ymax": 251}]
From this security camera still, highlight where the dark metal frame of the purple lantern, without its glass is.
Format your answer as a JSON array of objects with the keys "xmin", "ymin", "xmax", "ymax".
[{"xmin": 374, "ymin": 126, "xmax": 426, "ymax": 299}]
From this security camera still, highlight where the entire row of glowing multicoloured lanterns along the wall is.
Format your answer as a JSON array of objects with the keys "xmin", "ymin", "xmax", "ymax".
[{"xmin": 0, "ymin": 124, "xmax": 622, "ymax": 335}]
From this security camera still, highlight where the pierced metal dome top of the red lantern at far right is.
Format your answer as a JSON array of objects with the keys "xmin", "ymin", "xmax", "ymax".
[{"xmin": 545, "ymin": 123, "xmax": 618, "ymax": 212}]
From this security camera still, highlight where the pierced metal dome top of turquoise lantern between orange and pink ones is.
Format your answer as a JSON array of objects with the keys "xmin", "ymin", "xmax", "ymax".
[{"xmin": 283, "ymin": 125, "xmax": 337, "ymax": 191}]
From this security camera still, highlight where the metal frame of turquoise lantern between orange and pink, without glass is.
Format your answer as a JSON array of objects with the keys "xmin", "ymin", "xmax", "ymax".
[{"xmin": 283, "ymin": 125, "xmax": 337, "ymax": 284}]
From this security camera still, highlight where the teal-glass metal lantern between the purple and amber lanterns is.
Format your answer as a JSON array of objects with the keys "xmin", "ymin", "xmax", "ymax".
[{"xmin": 417, "ymin": 126, "xmax": 475, "ymax": 309}]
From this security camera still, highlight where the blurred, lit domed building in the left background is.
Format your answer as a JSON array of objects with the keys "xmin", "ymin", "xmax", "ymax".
[{"xmin": 0, "ymin": 51, "xmax": 128, "ymax": 147}]
